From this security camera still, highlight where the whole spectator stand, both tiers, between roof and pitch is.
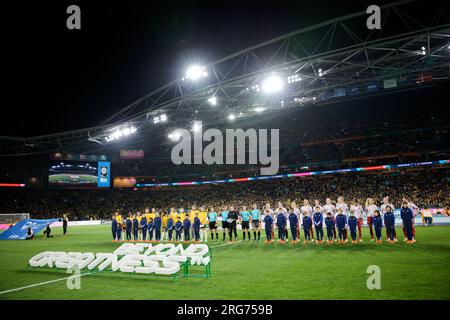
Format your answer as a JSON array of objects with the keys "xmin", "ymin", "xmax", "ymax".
[{"xmin": 0, "ymin": 87, "xmax": 450, "ymax": 220}]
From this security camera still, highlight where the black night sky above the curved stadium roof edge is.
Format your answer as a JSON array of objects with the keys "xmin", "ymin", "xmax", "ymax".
[{"xmin": 0, "ymin": 0, "xmax": 398, "ymax": 136}]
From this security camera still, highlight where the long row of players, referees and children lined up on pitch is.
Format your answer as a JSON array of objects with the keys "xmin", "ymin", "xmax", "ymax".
[{"xmin": 112, "ymin": 197, "xmax": 418, "ymax": 243}]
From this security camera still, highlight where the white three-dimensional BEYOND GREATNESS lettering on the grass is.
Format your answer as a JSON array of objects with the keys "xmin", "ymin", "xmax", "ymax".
[{"xmin": 28, "ymin": 243, "xmax": 211, "ymax": 275}]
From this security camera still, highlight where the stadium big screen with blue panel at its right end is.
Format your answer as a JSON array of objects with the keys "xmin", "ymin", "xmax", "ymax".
[{"xmin": 48, "ymin": 161, "xmax": 110, "ymax": 189}]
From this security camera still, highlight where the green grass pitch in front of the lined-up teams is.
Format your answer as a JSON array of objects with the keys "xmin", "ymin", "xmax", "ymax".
[{"xmin": 0, "ymin": 226, "xmax": 450, "ymax": 300}]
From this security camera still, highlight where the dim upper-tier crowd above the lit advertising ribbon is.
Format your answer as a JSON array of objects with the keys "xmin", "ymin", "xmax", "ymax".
[{"xmin": 114, "ymin": 92, "xmax": 450, "ymax": 181}]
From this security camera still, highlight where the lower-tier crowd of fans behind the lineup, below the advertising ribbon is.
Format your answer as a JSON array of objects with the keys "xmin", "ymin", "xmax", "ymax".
[{"xmin": 0, "ymin": 167, "xmax": 450, "ymax": 220}]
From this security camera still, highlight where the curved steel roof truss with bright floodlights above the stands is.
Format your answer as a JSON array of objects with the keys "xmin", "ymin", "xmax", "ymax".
[{"xmin": 0, "ymin": 1, "xmax": 450, "ymax": 155}]
